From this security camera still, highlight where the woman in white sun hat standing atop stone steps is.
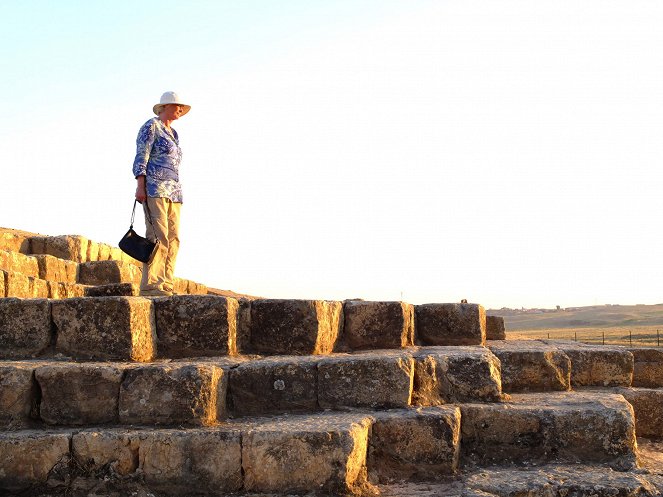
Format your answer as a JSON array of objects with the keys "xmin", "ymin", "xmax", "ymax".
[{"xmin": 133, "ymin": 91, "xmax": 191, "ymax": 296}]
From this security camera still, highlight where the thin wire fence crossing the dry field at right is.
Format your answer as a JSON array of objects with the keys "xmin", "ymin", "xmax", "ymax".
[{"xmin": 527, "ymin": 329, "xmax": 663, "ymax": 347}]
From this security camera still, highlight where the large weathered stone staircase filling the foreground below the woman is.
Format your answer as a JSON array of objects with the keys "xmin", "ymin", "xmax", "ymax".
[{"xmin": 0, "ymin": 233, "xmax": 663, "ymax": 497}]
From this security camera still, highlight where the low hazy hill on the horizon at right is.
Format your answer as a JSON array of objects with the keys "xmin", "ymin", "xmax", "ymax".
[{"xmin": 486, "ymin": 304, "xmax": 663, "ymax": 331}]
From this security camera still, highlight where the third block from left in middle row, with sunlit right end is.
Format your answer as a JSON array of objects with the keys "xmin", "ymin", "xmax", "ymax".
[{"xmin": 120, "ymin": 364, "xmax": 222, "ymax": 425}]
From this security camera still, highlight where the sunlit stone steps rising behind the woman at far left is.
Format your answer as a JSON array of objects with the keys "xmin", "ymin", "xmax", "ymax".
[{"xmin": 0, "ymin": 228, "xmax": 207, "ymax": 299}]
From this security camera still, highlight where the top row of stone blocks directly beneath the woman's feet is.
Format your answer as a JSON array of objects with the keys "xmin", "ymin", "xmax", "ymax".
[{"xmin": 0, "ymin": 294, "xmax": 485, "ymax": 361}]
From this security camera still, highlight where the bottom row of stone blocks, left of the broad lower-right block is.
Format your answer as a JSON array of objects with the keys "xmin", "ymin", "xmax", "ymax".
[{"xmin": 0, "ymin": 406, "xmax": 460, "ymax": 495}]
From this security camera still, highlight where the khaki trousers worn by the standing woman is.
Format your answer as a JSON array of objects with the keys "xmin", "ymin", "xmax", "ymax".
[{"xmin": 140, "ymin": 197, "xmax": 182, "ymax": 292}]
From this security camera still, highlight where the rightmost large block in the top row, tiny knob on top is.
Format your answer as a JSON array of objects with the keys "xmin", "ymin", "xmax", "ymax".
[{"xmin": 415, "ymin": 304, "xmax": 486, "ymax": 345}]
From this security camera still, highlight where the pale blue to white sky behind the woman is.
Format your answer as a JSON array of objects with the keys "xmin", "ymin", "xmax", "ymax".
[{"xmin": 0, "ymin": 0, "xmax": 663, "ymax": 307}]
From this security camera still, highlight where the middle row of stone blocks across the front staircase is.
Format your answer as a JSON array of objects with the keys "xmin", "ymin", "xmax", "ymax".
[{"xmin": 0, "ymin": 347, "xmax": 501, "ymax": 429}]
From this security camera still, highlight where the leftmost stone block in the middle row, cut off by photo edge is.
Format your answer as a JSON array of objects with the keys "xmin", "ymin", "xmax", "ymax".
[{"xmin": 0, "ymin": 362, "xmax": 37, "ymax": 429}]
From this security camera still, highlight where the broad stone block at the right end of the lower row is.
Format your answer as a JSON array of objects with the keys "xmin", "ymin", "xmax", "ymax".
[{"xmin": 460, "ymin": 392, "xmax": 636, "ymax": 470}]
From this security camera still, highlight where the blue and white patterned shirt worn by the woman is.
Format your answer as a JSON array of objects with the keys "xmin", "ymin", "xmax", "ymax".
[{"xmin": 133, "ymin": 117, "xmax": 182, "ymax": 203}]
